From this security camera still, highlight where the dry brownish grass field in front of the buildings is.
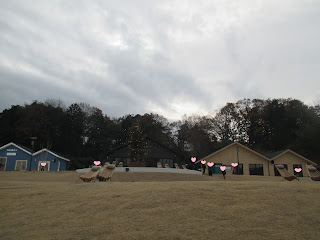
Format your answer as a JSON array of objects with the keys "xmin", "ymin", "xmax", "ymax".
[{"xmin": 0, "ymin": 172, "xmax": 320, "ymax": 240}]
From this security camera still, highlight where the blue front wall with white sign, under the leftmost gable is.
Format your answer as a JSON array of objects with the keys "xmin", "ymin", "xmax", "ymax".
[{"xmin": 0, "ymin": 145, "xmax": 31, "ymax": 171}]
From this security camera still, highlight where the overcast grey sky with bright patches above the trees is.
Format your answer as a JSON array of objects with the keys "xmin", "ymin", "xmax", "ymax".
[{"xmin": 0, "ymin": 0, "xmax": 320, "ymax": 120}]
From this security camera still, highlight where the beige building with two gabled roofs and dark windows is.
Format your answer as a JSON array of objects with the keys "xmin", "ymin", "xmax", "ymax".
[{"xmin": 196, "ymin": 142, "xmax": 316, "ymax": 176}]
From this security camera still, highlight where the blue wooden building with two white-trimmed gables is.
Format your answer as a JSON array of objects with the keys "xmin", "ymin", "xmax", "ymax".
[{"xmin": 0, "ymin": 142, "xmax": 70, "ymax": 171}]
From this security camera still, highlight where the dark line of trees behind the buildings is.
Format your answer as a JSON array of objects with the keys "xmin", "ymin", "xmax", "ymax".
[{"xmin": 0, "ymin": 99, "xmax": 320, "ymax": 169}]
